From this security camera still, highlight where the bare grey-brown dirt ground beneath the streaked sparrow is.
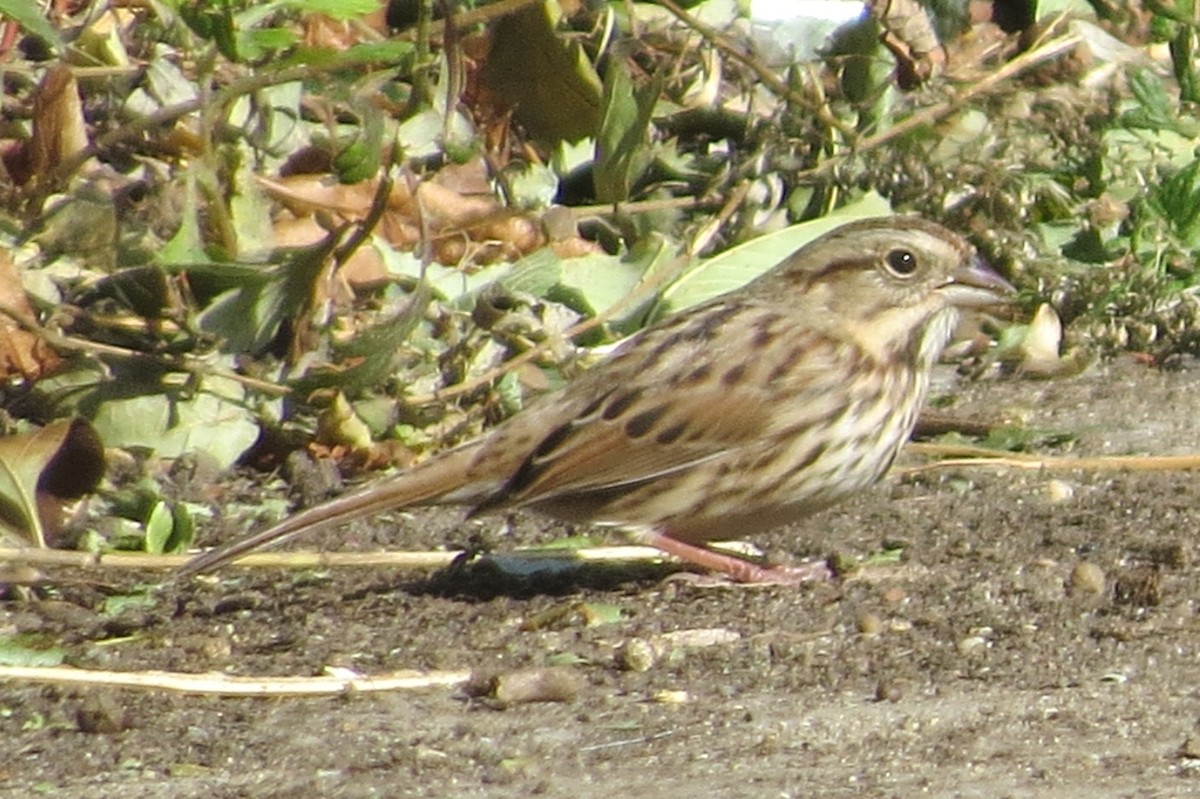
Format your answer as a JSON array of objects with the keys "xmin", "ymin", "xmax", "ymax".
[{"xmin": 0, "ymin": 359, "xmax": 1200, "ymax": 799}]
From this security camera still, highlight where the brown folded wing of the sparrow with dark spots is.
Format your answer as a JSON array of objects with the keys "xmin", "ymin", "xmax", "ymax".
[{"xmin": 476, "ymin": 316, "xmax": 847, "ymax": 510}]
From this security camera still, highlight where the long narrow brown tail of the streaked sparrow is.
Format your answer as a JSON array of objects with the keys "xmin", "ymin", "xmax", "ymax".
[{"xmin": 176, "ymin": 444, "xmax": 479, "ymax": 577}]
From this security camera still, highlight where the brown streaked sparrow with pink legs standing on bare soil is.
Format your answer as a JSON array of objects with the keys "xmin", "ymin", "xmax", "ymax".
[{"xmin": 184, "ymin": 217, "xmax": 1012, "ymax": 582}]
